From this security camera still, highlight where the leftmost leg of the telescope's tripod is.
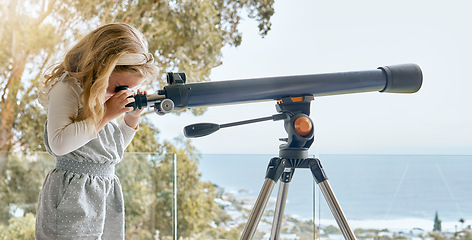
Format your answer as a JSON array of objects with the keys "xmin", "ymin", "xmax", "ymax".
[{"xmin": 241, "ymin": 158, "xmax": 286, "ymax": 240}]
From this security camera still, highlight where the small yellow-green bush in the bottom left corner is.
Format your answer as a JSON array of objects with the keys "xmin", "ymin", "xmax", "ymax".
[{"xmin": 0, "ymin": 213, "xmax": 36, "ymax": 240}]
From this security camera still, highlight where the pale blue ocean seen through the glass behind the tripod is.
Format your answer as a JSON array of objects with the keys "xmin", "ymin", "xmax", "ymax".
[{"xmin": 199, "ymin": 154, "xmax": 472, "ymax": 231}]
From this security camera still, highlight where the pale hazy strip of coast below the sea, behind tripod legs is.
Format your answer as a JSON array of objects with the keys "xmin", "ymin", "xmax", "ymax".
[{"xmin": 215, "ymin": 189, "xmax": 472, "ymax": 240}]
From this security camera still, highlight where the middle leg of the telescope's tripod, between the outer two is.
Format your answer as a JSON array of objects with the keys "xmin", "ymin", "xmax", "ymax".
[{"xmin": 270, "ymin": 168, "xmax": 295, "ymax": 240}]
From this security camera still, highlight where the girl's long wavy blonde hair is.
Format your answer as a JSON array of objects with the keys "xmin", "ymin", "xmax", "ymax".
[{"xmin": 44, "ymin": 23, "xmax": 157, "ymax": 124}]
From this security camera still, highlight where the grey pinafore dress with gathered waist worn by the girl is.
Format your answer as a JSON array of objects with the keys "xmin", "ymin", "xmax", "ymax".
[{"xmin": 36, "ymin": 122, "xmax": 126, "ymax": 239}]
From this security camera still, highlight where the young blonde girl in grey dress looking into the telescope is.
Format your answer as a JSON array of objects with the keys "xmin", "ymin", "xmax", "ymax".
[{"xmin": 36, "ymin": 23, "xmax": 157, "ymax": 239}]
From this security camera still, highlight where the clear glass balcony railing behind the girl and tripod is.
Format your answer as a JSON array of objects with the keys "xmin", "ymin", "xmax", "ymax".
[{"xmin": 0, "ymin": 153, "xmax": 472, "ymax": 240}]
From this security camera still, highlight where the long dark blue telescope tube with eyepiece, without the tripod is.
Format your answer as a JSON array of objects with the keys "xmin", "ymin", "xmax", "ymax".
[{"xmin": 129, "ymin": 64, "xmax": 422, "ymax": 115}]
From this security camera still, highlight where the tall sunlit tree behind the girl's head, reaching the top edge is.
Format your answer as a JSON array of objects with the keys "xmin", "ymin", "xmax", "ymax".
[{"xmin": 0, "ymin": 0, "xmax": 274, "ymax": 174}]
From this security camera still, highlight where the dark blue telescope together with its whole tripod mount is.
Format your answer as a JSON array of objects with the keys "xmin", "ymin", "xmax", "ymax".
[{"xmin": 131, "ymin": 64, "xmax": 423, "ymax": 240}]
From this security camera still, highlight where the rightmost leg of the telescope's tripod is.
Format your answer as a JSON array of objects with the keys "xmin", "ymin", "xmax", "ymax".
[{"xmin": 310, "ymin": 158, "xmax": 356, "ymax": 240}]
